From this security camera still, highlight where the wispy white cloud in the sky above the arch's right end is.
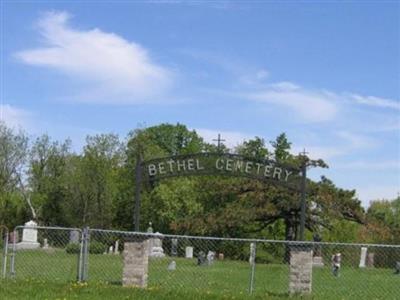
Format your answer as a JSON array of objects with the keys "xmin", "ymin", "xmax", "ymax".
[{"xmin": 242, "ymin": 82, "xmax": 338, "ymax": 122}]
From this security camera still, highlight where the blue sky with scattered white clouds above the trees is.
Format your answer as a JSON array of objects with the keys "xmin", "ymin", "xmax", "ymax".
[{"xmin": 0, "ymin": 0, "xmax": 400, "ymax": 207}]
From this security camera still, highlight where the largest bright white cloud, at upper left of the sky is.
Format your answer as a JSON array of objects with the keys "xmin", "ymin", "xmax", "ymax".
[{"xmin": 16, "ymin": 12, "xmax": 173, "ymax": 103}]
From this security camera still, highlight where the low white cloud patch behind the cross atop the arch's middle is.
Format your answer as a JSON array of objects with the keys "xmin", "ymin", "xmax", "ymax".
[{"xmin": 195, "ymin": 128, "xmax": 254, "ymax": 149}]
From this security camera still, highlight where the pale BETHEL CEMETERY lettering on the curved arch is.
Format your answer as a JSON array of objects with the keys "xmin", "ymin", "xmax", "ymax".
[{"xmin": 145, "ymin": 157, "xmax": 296, "ymax": 182}]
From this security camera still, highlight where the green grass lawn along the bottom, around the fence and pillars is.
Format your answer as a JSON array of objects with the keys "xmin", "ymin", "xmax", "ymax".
[{"xmin": 0, "ymin": 250, "xmax": 400, "ymax": 300}]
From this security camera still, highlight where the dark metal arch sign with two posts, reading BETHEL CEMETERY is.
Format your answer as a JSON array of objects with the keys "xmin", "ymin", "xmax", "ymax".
[{"xmin": 134, "ymin": 152, "xmax": 306, "ymax": 237}]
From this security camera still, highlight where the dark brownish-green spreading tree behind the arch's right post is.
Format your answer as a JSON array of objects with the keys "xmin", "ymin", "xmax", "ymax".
[{"xmin": 173, "ymin": 134, "xmax": 363, "ymax": 244}]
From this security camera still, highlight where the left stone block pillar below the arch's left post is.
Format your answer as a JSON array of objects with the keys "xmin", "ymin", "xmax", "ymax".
[{"xmin": 122, "ymin": 240, "xmax": 149, "ymax": 288}]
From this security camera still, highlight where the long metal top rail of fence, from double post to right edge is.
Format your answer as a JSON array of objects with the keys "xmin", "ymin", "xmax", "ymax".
[{"xmin": 89, "ymin": 228, "xmax": 400, "ymax": 249}]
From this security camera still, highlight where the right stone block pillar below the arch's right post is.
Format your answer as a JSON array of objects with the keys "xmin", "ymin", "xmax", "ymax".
[{"xmin": 289, "ymin": 245, "xmax": 313, "ymax": 294}]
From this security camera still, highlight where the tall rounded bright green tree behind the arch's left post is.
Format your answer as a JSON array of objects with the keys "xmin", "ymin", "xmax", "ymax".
[{"xmin": 123, "ymin": 123, "xmax": 207, "ymax": 232}]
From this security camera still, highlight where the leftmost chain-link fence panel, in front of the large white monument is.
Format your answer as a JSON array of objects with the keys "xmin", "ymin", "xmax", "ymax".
[{"xmin": 10, "ymin": 226, "xmax": 83, "ymax": 282}]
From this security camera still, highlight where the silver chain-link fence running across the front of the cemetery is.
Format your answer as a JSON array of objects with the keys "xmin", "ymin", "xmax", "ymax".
[{"xmin": 3, "ymin": 227, "xmax": 400, "ymax": 299}]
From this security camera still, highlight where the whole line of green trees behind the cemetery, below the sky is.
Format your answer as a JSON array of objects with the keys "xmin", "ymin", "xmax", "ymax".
[{"xmin": 0, "ymin": 123, "xmax": 400, "ymax": 243}]
